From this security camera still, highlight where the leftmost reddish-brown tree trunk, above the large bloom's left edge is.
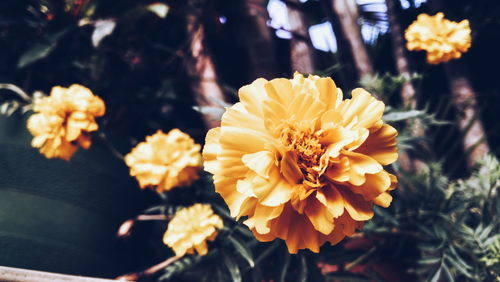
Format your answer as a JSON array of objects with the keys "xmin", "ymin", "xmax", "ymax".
[{"xmin": 186, "ymin": 4, "xmax": 224, "ymax": 128}]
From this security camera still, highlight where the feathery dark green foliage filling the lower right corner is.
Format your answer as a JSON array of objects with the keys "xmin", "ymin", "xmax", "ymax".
[{"xmin": 363, "ymin": 156, "xmax": 500, "ymax": 281}]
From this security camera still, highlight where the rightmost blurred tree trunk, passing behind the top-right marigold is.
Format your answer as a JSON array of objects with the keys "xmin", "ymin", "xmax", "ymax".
[{"xmin": 429, "ymin": 0, "xmax": 490, "ymax": 168}]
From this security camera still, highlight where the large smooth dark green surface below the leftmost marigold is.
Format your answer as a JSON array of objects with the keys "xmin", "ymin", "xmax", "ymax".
[{"xmin": 0, "ymin": 114, "xmax": 155, "ymax": 280}]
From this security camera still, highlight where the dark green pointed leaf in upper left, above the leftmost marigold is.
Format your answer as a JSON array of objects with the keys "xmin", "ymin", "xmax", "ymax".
[{"xmin": 17, "ymin": 28, "xmax": 69, "ymax": 69}]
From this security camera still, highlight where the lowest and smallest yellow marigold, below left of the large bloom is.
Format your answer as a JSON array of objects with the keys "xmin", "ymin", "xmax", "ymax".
[{"xmin": 163, "ymin": 204, "xmax": 223, "ymax": 256}]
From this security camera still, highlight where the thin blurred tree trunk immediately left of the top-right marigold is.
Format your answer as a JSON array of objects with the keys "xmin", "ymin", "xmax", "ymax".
[{"xmin": 385, "ymin": 0, "xmax": 417, "ymax": 109}]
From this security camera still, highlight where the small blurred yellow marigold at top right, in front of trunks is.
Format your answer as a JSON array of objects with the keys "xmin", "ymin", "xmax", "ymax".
[{"xmin": 405, "ymin": 13, "xmax": 471, "ymax": 64}]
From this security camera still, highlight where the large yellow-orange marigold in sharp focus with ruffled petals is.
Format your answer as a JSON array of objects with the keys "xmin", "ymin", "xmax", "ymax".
[{"xmin": 203, "ymin": 74, "xmax": 398, "ymax": 253}]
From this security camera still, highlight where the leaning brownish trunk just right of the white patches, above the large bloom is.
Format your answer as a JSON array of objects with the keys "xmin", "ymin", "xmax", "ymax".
[{"xmin": 330, "ymin": 0, "xmax": 375, "ymax": 79}]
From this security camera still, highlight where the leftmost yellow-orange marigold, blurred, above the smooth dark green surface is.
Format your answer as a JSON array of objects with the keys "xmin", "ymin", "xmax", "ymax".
[{"xmin": 27, "ymin": 84, "xmax": 105, "ymax": 160}]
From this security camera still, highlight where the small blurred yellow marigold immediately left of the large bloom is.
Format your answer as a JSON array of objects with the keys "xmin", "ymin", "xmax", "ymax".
[{"xmin": 125, "ymin": 129, "xmax": 202, "ymax": 192}]
